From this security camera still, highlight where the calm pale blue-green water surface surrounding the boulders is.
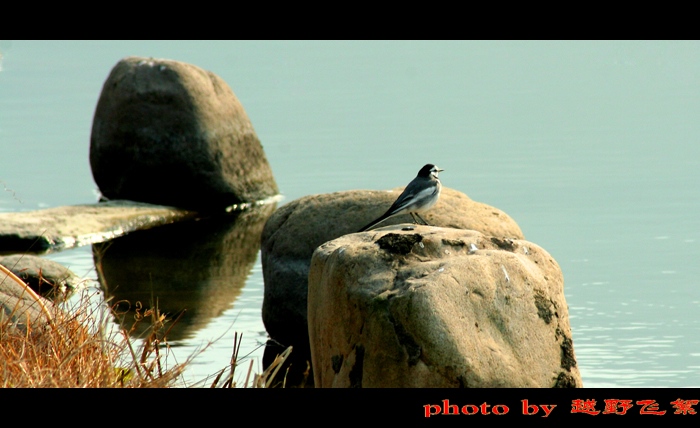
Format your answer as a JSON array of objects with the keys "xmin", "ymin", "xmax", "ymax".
[{"xmin": 0, "ymin": 41, "xmax": 700, "ymax": 387}]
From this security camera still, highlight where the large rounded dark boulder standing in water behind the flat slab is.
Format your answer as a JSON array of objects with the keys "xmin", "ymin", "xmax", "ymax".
[{"xmin": 90, "ymin": 57, "xmax": 279, "ymax": 211}]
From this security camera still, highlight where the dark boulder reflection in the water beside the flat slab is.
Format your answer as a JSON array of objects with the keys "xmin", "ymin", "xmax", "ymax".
[{"xmin": 93, "ymin": 204, "xmax": 275, "ymax": 341}]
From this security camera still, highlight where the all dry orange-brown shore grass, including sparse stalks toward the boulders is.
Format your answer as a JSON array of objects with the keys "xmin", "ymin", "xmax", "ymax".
[{"xmin": 0, "ymin": 264, "xmax": 291, "ymax": 388}]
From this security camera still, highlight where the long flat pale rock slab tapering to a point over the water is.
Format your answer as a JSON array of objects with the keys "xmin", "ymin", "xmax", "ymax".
[{"xmin": 0, "ymin": 200, "xmax": 201, "ymax": 254}]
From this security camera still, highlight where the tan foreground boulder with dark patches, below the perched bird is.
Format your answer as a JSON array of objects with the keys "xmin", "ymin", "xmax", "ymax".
[{"xmin": 308, "ymin": 226, "xmax": 582, "ymax": 388}]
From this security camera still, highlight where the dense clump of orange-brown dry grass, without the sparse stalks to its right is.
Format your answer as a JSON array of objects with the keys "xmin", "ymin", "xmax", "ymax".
[{"xmin": 0, "ymin": 284, "xmax": 184, "ymax": 388}]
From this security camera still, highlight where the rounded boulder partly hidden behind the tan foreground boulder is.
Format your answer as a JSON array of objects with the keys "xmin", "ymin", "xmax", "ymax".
[{"xmin": 261, "ymin": 187, "xmax": 523, "ymax": 384}]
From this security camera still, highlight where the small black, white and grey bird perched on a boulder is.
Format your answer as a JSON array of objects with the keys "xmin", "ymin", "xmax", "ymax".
[{"xmin": 360, "ymin": 163, "xmax": 444, "ymax": 232}]
